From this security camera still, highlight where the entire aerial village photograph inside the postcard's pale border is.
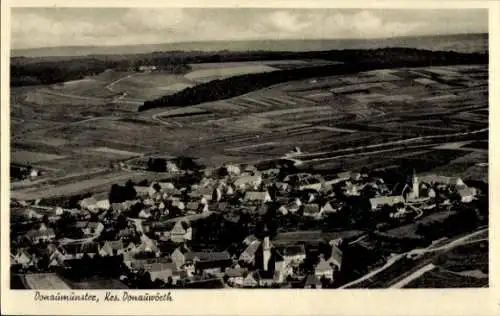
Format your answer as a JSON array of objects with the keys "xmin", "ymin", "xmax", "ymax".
[{"xmin": 2, "ymin": 6, "xmax": 490, "ymax": 294}]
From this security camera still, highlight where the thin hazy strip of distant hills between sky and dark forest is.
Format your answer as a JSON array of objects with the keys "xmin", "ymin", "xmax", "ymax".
[{"xmin": 10, "ymin": 32, "xmax": 489, "ymax": 51}]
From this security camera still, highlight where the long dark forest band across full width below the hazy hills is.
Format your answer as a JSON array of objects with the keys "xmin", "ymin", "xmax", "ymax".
[{"xmin": 11, "ymin": 48, "xmax": 487, "ymax": 86}]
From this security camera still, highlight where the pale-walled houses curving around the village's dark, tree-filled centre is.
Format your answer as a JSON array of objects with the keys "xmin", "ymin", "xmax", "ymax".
[{"xmin": 11, "ymin": 159, "xmax": 477, "ymax": 288}]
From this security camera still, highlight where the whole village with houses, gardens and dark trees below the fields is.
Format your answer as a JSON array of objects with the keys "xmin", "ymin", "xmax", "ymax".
[{"xmin": 11, "ymin": 156, "xmax": 479, "ymax": 288}]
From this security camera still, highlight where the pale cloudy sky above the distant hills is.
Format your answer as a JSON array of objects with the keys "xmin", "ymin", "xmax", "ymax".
[{"xmin": 11, "ymin": 8, "xmax": 488, "ymax": 49}]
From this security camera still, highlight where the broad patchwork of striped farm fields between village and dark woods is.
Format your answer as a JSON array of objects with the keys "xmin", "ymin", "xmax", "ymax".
[{"xmin": 11, "ymin": 61, "xmax": 488, "ymax": 197}]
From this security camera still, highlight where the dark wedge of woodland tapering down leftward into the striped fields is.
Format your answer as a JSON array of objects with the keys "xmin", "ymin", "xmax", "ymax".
[{"xmin": 138, "ymin": 48, "xmax": 488, "ymax": 111}]
